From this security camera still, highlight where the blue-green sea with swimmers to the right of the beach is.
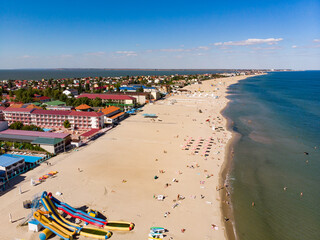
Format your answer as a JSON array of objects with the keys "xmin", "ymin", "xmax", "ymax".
[{"xmin": 223, "ymin": 71, "xmax": 320, "ymax": 240}]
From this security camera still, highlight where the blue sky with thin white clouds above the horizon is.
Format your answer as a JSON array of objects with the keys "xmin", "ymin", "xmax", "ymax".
[{"xmin": 0, "ymin": 0, "xmax": 320, "ymax": 69}]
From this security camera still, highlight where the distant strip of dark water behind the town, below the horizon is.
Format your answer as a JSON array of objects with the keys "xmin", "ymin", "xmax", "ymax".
[{"xmin": 0, "ymin": 69, "xmax": 232, "ymax": 80}]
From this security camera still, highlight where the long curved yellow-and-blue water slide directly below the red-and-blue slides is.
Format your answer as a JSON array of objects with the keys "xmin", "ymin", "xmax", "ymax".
[{"xmin": 41, "ymin": 192, "xmax": 112, "ymax": 239}]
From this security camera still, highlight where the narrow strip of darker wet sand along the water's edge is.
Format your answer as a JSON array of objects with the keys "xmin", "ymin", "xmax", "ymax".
[{"xmin": 219, "ymin": 73, "xmax": 266, "ymax": 240}]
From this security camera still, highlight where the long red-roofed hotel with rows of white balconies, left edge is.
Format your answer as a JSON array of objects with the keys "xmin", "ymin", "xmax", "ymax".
[{"xmin": 3, "ymin": 107, "xmax": 104, "ymax": 129}]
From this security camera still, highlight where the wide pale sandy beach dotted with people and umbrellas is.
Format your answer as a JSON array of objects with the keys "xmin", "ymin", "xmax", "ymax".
[{"xmin": 0, "ymin": 76, "xmax": 255, "ymax": 240}]
